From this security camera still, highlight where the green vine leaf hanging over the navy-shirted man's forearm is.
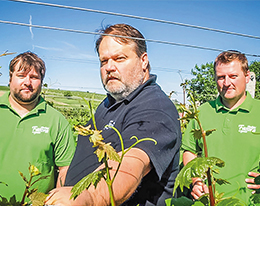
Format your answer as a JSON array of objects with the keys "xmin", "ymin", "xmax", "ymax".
[{"xmin": 70, "ymin": 168, "xmax": 106, "ymax": 199}]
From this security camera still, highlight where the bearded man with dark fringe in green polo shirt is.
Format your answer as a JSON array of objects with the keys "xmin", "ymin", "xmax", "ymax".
[{"xmin": 0, "ymin": 52, "xmax": 75, "ymax": 204}]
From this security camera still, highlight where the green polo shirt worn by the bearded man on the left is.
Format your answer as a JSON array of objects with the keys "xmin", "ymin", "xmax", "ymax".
[{"xmin": 0, "ymin": 93, "xmax": 75, "ymax": 201}]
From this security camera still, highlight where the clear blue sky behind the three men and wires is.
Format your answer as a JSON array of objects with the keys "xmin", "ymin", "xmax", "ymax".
[{"xmin": 0, "ymin": 0, "xmax": 260, "ymax": 101}]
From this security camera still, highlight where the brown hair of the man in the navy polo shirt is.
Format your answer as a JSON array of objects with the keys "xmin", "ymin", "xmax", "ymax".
[{"xmin": 96, "ymin": 24, "xmax": 150, "ymax": 70}]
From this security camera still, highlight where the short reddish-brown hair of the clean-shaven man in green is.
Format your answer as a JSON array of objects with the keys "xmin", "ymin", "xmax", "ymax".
[{"xmin": 214, "ymin": 50, "xmax": 249, "ymax": 75}]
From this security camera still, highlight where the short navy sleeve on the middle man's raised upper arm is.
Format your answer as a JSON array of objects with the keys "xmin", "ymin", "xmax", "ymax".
[{"xmin": 116, "ymin": 103, "xmax": 181, "ymax": 178}]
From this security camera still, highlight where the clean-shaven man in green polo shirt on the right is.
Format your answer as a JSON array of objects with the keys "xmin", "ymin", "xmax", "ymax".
[{"xmin": 182, "ymin": 51, "xmax": 260, "ymax": 205}]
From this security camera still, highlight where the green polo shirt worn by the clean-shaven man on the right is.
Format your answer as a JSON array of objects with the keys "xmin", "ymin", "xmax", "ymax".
[{"xmin": 182, "ymin": 93, "xmax": 260, "ymax": 204}]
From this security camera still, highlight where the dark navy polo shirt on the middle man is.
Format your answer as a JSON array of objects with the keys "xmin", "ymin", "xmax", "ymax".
[{"xmin": 65, "ymin": 75, "xmax": 181, "ymax": 205}]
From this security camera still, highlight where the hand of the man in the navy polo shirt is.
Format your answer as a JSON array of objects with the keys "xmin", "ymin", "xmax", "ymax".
[{"xmin": 45, "ymin": 187, "xmax": 77, "ymax": 206}]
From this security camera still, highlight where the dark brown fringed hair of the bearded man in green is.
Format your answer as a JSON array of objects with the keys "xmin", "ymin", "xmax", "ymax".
[{"xmin": 9, "ymin": 51, "xmax": 46, "ymax": 81}]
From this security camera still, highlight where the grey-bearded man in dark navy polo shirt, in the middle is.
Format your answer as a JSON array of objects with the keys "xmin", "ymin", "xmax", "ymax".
[{"xmin": 46, "ymin": 24, "xmax": 181, "ymax": 205}]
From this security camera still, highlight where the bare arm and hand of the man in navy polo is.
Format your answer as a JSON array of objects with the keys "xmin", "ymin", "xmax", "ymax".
[{"xmin": 46, "ymin": 148, "xmax": 151, "ymax": 206}]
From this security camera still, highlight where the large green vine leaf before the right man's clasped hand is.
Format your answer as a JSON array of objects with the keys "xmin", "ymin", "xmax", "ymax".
[{"xmin": 173, "ymin": 157, "xmax": 225, "ymax": 194}]
